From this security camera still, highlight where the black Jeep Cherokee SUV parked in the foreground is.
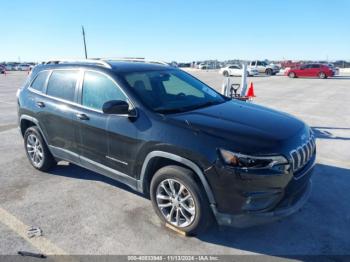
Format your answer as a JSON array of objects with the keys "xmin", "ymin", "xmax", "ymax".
[{"xmin": 17, "ymin": 60, "xmax": 316, "ymax": 233}]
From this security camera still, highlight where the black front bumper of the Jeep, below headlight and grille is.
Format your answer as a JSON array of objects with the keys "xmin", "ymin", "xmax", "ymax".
[{"xmin": 206, "ymin": 155, "xmax": 316, "ymax": 228}]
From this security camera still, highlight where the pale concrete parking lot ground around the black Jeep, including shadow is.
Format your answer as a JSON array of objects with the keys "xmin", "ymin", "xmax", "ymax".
[{"xmin": 0, "ymin": 71, "xmax": 350, "ymax": 258}]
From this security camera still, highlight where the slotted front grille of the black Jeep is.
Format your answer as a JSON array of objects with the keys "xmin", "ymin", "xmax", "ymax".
[{"xmin": 290, "ymin": 136, "xmax": 316, "ymax": 173}]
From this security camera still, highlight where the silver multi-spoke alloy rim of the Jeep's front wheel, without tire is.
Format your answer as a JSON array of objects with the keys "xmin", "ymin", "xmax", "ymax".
[{"xmin": 156, "ymin": 179, "xmax": 196, "ymax": 228}]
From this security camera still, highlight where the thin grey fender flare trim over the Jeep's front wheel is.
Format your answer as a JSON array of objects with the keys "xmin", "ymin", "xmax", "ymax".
[{"xmin": 138, "ymin": 151, "xmax": 215, "ymax": 205}]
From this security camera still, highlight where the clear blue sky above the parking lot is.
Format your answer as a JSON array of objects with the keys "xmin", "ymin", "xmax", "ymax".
[{"xmin": 0, "ymin": 0, "xmax": 350, "ymax": 61}]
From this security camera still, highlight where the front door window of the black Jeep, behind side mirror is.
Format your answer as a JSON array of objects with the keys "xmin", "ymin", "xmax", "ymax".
[{"xmin": 82, "ymin": 71, "xmax": 127, "ymax": 110}]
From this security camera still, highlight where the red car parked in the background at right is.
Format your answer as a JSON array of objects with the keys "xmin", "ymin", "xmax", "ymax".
[{"xmin": 285, "ymin": 64, "xmax": 335, "ymax": 79}]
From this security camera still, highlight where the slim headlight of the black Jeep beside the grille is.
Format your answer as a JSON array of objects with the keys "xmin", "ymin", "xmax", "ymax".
[{"xmin": 219, "ymin": 149, "xmax": 288, "ymax": 169}]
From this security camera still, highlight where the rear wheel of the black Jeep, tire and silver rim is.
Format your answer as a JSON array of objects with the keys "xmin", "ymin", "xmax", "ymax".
[{"xmin": 24, "ymin": 126, "xmax": 56, "ymax": 171}]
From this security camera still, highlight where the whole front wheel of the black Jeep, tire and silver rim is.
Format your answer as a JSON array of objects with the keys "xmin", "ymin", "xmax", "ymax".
[{"xmin": 150, "ymin": 166, "xmax": 212, "ymax": 235}]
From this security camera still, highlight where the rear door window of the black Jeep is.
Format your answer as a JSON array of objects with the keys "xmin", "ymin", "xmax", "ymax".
[{"xmin": 47, "ymin": 70, "xmax": 79, "ymax": 101}]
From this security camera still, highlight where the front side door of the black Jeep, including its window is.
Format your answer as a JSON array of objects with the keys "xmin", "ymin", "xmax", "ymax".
[{"xmin": 75, "ymin": 70, "xmax": 135, "ymax": 176}]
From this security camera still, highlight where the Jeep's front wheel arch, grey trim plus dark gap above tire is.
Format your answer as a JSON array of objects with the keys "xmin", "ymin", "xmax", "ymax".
[{"xmin": 139, "ymin": 151, "xmax": 215, "ymax": 205}]
